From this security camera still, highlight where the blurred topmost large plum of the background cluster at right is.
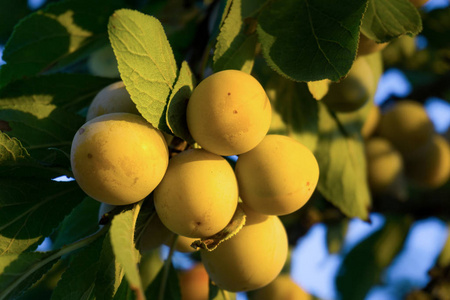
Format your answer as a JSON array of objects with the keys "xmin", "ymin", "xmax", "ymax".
[{"xmin": 377, "ymin": 100, "xmax": 435, "ymax": 158}]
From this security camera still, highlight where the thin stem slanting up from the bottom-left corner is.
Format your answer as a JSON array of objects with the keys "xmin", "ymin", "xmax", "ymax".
[{"xmin": 0, "ymin": 226, "xmax": 109, "ymax": 300}]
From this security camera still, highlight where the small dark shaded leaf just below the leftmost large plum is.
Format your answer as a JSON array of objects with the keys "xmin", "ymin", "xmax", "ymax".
[{"xmin": 52, "ymin": 197, "xmax": 100, "ymax": 249}]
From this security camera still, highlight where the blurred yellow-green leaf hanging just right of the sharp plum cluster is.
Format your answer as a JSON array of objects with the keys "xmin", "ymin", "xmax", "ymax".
[{"xmin": 314, "ymin": 103, "xmax": 370, "ymax": 220}]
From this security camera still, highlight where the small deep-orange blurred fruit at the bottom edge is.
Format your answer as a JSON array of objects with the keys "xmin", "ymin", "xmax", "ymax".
[{"xmin": 178, "ymin": 263, "xmax": 209, "ymax": 300}]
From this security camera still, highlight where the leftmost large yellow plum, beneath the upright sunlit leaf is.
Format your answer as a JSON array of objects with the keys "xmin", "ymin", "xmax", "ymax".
[{"xmin": 70, "ymin": 113, "xmax": 169, "ymax": 205}]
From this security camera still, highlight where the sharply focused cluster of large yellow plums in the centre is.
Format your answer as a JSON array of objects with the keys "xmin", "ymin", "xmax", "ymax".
[{"xmin": 71, "ymin": 70, "xmax": 319, "ymax": 292}]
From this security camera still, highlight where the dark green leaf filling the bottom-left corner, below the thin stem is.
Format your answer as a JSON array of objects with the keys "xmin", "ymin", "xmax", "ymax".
[{"xmin": 0, "ymin": 252, "xmax": 59, "ymax": 299}]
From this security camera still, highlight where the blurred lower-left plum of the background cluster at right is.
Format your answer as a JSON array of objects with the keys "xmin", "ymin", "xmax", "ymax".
[{"xmin": 365, "ymin": 137, "xmax": 404, "ymax": 194}]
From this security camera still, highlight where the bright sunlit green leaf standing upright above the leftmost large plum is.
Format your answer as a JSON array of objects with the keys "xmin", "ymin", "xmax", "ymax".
[{"xmin": 108, "ymin": 9, "xmax": 177, "ymax": 133}]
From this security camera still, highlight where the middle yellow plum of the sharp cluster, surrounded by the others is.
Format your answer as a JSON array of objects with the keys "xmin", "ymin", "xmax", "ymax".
[{"xmin": 154, "ymin": 149, "xmax": 238, "ymax": 238}]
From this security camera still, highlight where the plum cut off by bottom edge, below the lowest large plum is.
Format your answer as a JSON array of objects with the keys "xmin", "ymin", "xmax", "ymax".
[{"xmin": 249, "ymin": 274, "xmax": 313, "ymax": 300}]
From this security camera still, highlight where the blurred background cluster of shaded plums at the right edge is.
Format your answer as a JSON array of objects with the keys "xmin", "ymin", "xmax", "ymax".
[{"xmin": 363, "ymin": 99, "xmax": 450, "ymax": 197}]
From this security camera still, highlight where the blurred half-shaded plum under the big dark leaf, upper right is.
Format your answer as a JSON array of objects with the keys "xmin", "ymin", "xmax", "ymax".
[{"xmin": 322, "ymin": 57, "xmax": 376, "ymax": 112}]
